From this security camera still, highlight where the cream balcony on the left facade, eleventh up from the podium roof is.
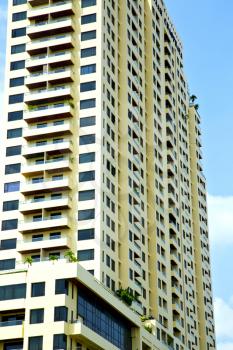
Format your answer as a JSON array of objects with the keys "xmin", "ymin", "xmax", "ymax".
[{"xmin": 25, "ymin": 50, "xmax": 74, "ymax": 72}]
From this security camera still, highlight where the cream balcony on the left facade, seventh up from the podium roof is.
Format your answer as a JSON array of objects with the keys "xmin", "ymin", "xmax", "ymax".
[{"xmin": 23, "ymin": 120, "xmax": 72, "ymax": 141}]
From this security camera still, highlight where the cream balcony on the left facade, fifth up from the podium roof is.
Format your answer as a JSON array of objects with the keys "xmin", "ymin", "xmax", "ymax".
[{"xmin": 21, "ymin": 157, "xmax": 72, "ymax": 176}]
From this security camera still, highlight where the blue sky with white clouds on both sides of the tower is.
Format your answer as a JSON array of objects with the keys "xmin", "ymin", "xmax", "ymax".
[{"xmin": 0, "ymin": 0, "xmax": 233, "ymax": 350}]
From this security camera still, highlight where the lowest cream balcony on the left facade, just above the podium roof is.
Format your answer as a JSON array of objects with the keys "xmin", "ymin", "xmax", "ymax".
[{"xmin": 17, "ymin": 237, "xmax": 71, "ymax": 254}]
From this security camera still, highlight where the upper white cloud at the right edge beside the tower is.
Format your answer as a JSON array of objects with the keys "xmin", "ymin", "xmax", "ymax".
[{"xmin": 208, "ymin": 195, "xmax": 233, "ymax": 246}]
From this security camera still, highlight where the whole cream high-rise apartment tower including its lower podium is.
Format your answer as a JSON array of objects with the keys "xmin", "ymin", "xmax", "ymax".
[{"xmin": 0, "ymin": 0, "xmax": 215, "ymax": 350}]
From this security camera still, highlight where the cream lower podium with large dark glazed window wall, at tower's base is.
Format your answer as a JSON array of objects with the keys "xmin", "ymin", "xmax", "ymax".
[{"xmin": 0, "ymin": 260, "xmax": 186, "ymax": 350}]
